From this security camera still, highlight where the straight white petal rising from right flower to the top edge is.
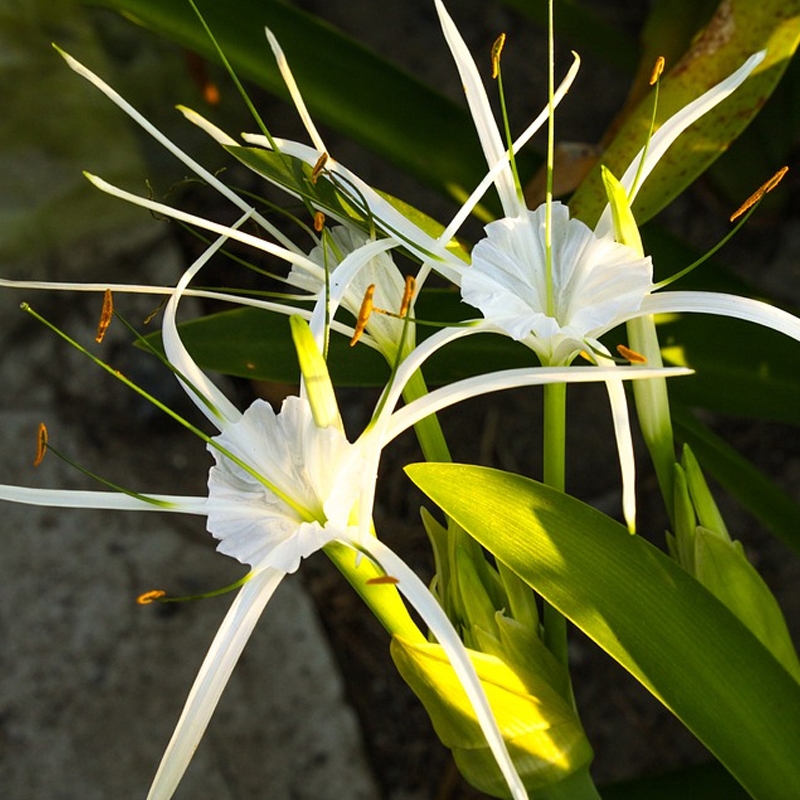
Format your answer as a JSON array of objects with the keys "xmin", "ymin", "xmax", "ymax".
[{"xmin": 436, "ymin": 0, "xmax": 524, "ymax": 216}]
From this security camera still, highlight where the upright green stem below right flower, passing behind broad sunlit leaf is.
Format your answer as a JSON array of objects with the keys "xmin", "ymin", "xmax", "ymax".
[{"xmin": 542, "ymin": 383, "xmax": 568, "ymax": 667}]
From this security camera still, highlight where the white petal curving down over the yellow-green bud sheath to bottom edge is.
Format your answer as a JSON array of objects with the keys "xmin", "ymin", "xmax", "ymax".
[{"xmin": 366, "ymin": 539, "xmax": 528, "ymax": 800}]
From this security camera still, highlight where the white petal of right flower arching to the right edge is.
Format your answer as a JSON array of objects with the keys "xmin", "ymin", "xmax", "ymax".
[{"xmin": 633, "ymin": 291, "xmax": 800, "ymax": 342}]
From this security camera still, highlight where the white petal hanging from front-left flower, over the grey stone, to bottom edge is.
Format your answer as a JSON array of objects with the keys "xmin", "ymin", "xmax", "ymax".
[{"xmin": 147, "ymin": 570, "xmax": 284, "ymax": 800}]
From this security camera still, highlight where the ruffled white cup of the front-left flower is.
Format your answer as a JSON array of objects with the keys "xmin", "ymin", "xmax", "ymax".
[{"xmin": 208, "ymin": 397, "xmax": 364, "ymax": 572}]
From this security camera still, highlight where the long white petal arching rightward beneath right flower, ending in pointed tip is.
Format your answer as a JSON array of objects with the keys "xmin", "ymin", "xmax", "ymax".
[{"xmin": 381, "ymin": 367, "xmax": 692, "ymax": 447}]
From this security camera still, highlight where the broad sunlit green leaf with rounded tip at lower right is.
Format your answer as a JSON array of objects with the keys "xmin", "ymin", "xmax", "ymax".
[{"xmin": 406, "ymin": 464, "xmax": 800, "ymax": 800}]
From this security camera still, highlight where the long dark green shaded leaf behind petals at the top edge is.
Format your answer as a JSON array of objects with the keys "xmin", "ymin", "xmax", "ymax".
[{"xmin": 99, "ymin": 0, "xmax": 533, "ymax": 199}]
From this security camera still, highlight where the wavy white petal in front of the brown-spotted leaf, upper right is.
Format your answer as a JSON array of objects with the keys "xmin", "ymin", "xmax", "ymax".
[{"xmin": 595, "ymin": 50, "xmax": 766, "ymax": 236}]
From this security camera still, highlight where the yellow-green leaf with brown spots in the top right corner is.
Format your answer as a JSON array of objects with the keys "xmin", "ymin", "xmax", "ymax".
[{"xmin": 570, "ymin": 0, "xmax": 800, "ymax": 224}]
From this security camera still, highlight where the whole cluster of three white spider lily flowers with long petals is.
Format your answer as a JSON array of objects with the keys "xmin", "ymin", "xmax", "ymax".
[{"xmin": 0, "ymin": 0, "xmax": 800, "ymax": 800}]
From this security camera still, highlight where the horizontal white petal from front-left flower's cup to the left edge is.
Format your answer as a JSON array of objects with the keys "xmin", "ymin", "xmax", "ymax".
[{"xmin": 0, "ymin": 484, "xmax": 208, "ymax": 516}]
